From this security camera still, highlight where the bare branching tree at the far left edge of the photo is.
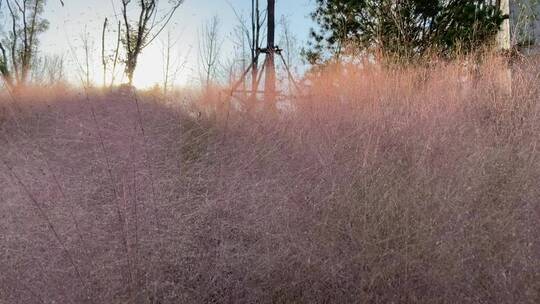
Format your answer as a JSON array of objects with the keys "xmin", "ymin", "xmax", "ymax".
[{"xmin": 0, "ymin": 0, "xmax": 49, "ymax": 88}]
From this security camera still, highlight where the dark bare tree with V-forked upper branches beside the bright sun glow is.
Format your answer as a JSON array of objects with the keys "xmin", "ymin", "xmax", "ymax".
[{"xmin": 121, "ymin": 0, "xmax": 184, "ymax": 85}]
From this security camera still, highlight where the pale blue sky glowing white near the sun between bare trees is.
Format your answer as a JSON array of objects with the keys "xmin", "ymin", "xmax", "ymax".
[{"xmin": 37, "ymin": 0, "xmax": 314, "ymax": 86}]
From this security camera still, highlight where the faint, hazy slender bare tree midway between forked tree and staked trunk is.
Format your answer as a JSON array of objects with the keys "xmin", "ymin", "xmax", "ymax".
[{"xmin": 199, "ymin": 16, "xmax": 223, "ymax": 89}]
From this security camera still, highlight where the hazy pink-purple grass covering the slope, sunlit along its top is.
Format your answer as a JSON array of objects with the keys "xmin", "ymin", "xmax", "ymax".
[{"xmin": 0, "ymin": 58, "xmax": 540, "ymax": 303}]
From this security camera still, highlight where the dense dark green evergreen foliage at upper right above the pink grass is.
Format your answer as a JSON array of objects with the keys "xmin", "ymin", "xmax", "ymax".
[{"xmin": 306, "ymin": 0, "xmax": 508, "ymax": 63}]
